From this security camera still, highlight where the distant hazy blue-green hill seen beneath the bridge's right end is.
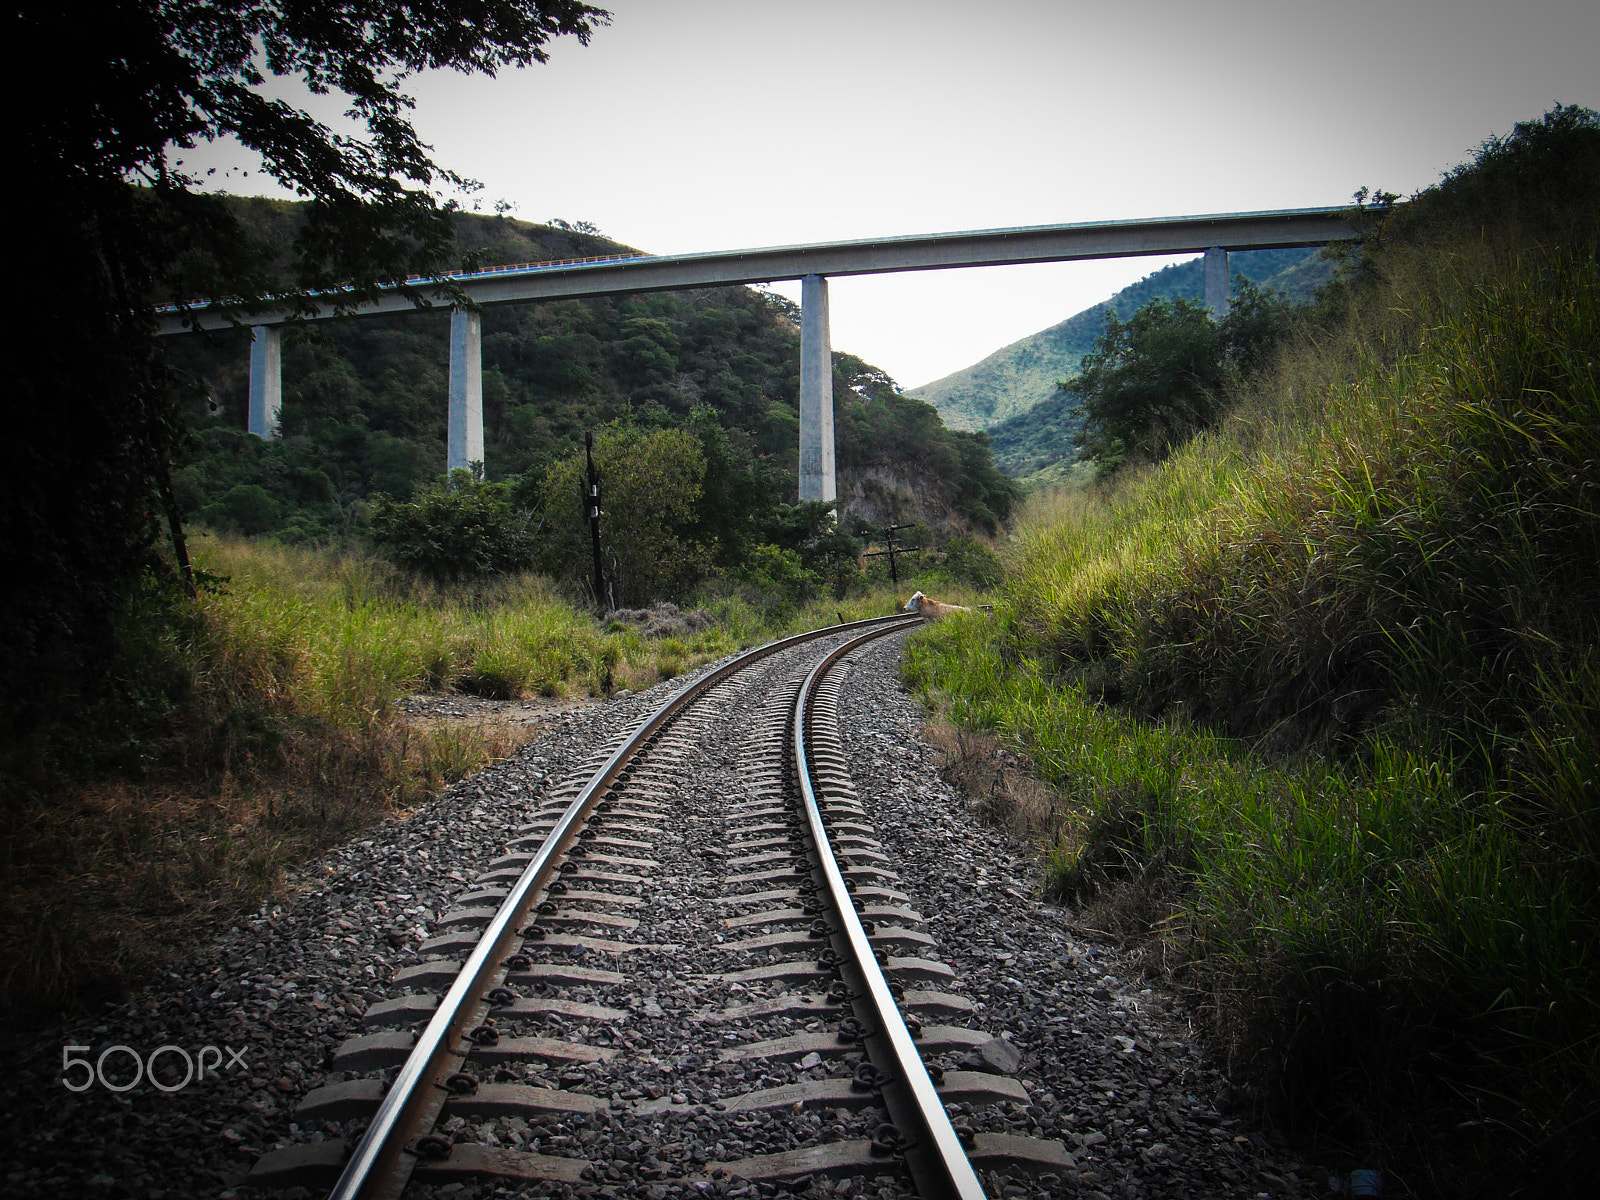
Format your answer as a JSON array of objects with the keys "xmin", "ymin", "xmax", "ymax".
[{"xmin": 909, "ymin": 250, "xmax": 1331, "ymax": 438}]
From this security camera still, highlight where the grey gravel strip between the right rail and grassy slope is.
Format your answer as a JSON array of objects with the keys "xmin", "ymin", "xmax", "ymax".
[{"xmin": 840, "ymin": 637, "xmax": 1320, "ymax": 1197}]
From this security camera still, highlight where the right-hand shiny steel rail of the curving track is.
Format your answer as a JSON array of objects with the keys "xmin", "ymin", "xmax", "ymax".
[{"xmin": 792, "ymin": 629, "xmax": 984, "ymax": 1200}]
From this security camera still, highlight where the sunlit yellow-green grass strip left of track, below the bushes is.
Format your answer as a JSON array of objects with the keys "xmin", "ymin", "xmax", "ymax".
[{"xmin": 194, "ymin": 534, "xmax": 970, "ymax": 713}]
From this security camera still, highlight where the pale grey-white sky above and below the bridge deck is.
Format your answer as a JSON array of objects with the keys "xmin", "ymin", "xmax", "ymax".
[{"xmin": 192, "ymin": 0, "xmax": 1600, "ymax": 387}]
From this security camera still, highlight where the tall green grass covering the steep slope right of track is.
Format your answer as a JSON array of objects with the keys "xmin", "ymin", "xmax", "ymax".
[{"xmin": 910, "ymin": 248, "xmax": 1600, "ymax": 1194}]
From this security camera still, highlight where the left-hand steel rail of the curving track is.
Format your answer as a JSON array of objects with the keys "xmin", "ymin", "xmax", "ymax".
[{"xmin": 328, "ymin": 613, "xmax": 907, "ymax": 1200}]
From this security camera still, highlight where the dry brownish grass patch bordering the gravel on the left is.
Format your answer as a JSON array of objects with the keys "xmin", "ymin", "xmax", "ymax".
[{"xmin": 0, "ymin": 704, "xmax": 538, "ymax": 1026}]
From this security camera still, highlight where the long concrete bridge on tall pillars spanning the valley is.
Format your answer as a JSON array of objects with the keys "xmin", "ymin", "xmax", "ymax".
[{"xmin": 162, "ymin": 208, "xmax": 1355, "ymax": 501}]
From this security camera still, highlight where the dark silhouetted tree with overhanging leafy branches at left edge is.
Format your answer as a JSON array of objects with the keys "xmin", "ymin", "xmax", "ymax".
[{"xmin": 0, "ymin": 0, "xmax": 606, "ymax": 736}]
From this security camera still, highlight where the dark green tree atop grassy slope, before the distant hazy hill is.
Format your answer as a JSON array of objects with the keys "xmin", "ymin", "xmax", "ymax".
[{"xmin": 1056, "ymin": 277, "xmax": 1290, "ymax": 474}]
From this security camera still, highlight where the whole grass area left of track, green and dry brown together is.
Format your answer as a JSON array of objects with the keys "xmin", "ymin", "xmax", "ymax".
[{"xmin": 0, "ymin": 533, "xmax": 966, "ymax": 1021}]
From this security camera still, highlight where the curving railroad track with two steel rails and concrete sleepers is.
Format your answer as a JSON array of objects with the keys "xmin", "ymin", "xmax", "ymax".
[{"xmin": 248, "ymin": 618, "xmax": 1072, "ymax": 1200}]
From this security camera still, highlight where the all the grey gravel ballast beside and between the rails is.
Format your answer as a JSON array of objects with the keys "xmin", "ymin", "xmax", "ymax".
[{"xmin": 0, "ymin": 635, "xmax": 1314, "ymax": 1200}]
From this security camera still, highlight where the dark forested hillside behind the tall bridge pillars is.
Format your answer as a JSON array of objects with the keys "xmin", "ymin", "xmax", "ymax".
[{"xmin": 173, "ymin": 200, "xmax": 1011, "ymax": 541}]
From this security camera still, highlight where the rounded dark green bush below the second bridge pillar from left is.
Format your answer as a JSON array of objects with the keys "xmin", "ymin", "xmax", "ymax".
[{"xmin": 371, "ymin": 470, "xmax": 533, "ymax": 582}]
